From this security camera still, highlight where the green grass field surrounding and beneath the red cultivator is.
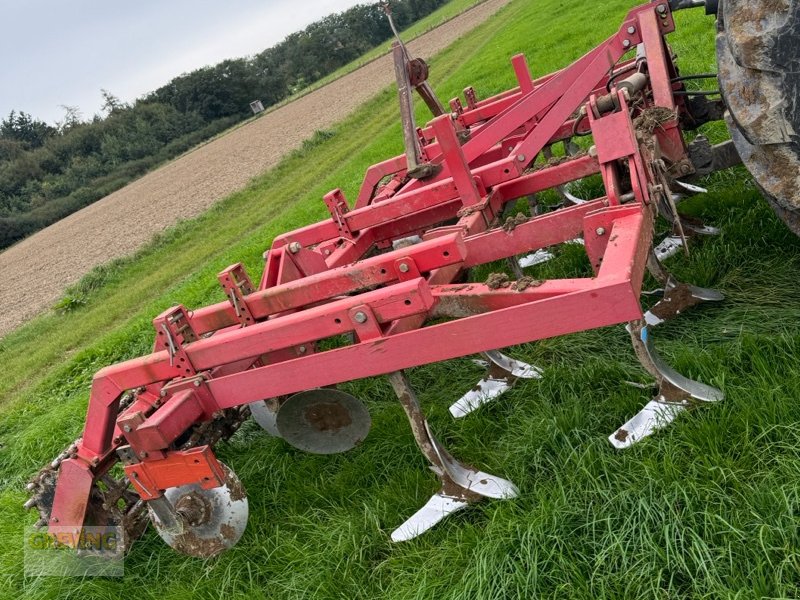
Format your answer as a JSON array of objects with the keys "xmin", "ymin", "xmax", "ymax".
[{"xmin": 0, "ymin": 0, "xmax": 800, "ymax": 600}]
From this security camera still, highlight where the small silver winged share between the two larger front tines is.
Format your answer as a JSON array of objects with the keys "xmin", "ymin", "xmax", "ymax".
[{"xmin": 450, "ymin": 350, "xmax": 542, "ymax": 419}]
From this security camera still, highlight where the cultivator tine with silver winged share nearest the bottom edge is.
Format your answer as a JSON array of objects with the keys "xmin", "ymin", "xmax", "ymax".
[{"xmin": 389, "ymin": 371, "xmax": 519, "ymax": 542}]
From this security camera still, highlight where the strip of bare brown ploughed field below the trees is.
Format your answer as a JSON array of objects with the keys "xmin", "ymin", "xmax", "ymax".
[{"xmin": 0, "ymin": 0, "xmax": 510, "ymax": 336}]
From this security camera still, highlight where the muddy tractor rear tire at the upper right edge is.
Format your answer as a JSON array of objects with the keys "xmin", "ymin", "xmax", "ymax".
[{"xmin": 717, "ymin": 0, "xmax": 800, "ymax": 235}]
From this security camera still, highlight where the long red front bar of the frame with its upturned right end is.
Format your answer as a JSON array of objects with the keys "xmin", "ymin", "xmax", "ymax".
[{"xmin": 206, "ymin": 205, "xmax": 651, "ymax": 408}]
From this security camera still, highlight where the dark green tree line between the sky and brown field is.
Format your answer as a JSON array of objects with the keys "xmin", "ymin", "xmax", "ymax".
[{"xmin": 0, "ymin": 0, "xmax": 447, "ymax": 248}]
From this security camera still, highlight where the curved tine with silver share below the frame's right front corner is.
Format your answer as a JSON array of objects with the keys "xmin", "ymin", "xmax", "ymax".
[{"xmin": 608, "ymin": 321, "xmax": 725, "ymax": 449}]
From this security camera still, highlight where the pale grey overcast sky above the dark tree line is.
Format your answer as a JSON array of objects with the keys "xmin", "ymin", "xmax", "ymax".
[{"xmin": 0, "ymin": 0, "xmax": 364, "ymax": 123}]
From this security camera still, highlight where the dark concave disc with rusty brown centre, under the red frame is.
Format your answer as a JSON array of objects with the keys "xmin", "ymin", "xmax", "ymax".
[{"xmin": 277, "ymin": 388, "xmax": 372, "ymax": 454}]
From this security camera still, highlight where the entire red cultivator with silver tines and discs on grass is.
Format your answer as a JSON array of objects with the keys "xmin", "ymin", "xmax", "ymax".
[{"xmin": 28, "ymin": 2, "xmax": 788, "ymax": 556}]
